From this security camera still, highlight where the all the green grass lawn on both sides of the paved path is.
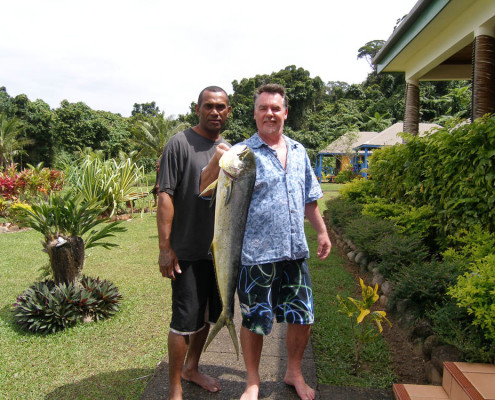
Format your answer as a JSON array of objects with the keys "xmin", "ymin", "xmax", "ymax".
[{"xmin": 0, "ymin": 184, "xmax": 391, "ymax": 400}]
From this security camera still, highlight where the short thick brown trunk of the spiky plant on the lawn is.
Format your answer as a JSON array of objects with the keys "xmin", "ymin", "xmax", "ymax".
[{"xmin": 46, "ymin": 236, "xmax": 84, "ymax": 285}]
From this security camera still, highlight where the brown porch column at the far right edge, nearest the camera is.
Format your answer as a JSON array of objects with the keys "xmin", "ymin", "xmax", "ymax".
[{"xmin": 472, "ymin": 28, "xmax": 495, "ymax": 121}]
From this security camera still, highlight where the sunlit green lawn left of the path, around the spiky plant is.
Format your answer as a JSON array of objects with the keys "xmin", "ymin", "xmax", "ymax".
[{"xmin": 0, "ymin": 215, "xmax": 170, "ymax": 400}]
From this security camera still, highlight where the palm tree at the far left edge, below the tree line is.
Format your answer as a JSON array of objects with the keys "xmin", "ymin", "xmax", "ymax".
[{"xmin": 0, "ymin": 113, "xmax": 34, "ymax": 170}]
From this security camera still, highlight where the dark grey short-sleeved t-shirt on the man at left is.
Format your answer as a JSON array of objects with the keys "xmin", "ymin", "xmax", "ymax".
[{"xmin": 159, "ymin": 128, "xmax": 227, "ymax": 261}]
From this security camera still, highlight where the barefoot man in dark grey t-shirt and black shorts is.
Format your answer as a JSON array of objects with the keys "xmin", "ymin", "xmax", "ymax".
[{"xmin": 157, "ymin": 86, "xmax": 231, "ymax": 400}]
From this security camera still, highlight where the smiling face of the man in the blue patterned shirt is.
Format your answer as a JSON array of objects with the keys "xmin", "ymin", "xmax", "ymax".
[{"xmin": 254, "ymin": 92, "xmax": 287, "ymax": 136}]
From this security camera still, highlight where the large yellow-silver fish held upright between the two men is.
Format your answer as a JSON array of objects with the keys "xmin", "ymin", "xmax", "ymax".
[{"xmin": 205, "ymin": 145, "xmax": 256, "ymax": 359}]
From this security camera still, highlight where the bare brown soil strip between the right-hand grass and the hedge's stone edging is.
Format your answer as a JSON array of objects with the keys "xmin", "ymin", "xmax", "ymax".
[{"xmin": 330, "ymin": 230, "xmax": 428, "ymax": 385}]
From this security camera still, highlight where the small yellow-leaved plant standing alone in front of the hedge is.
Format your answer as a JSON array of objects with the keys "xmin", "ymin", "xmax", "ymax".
[{"xmin": 337, "ymin": 278, "xmax": 392, "ymax": 374}]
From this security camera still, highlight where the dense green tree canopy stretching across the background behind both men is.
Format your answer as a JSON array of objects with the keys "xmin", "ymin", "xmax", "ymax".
[{"xmin": 0, "ymin": 40, "xmax": 471, "ymax": 168}]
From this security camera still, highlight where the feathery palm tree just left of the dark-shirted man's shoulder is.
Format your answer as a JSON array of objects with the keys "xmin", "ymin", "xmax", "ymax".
[{"xmin": 133, "ymin": 113, "xmax": 189, "ymax": 158}]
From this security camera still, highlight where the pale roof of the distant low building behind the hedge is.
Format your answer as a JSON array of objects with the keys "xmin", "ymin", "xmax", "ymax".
[{"xmin": 318, "ymin": 122, "xmax": 441, "ymax": 155}]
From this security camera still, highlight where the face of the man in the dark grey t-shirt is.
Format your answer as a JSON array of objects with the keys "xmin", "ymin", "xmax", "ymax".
[{"xmin": 196, "ymin": 91, "xmax": 231, "ymax": 134}]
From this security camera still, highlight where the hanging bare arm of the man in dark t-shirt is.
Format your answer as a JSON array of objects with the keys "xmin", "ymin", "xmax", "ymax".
[{"xmin": 156, "ymin": 192, "xmax": 182, "ymax": 279}]
